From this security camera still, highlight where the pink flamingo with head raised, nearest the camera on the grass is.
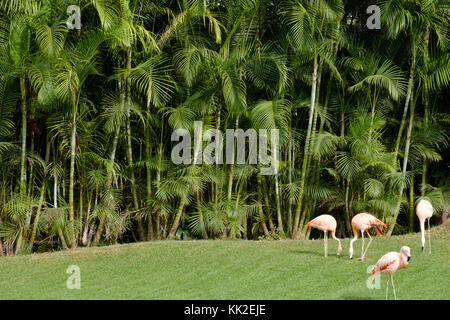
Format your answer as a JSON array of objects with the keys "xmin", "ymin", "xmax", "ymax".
[{"xmin": 370, "ymin": 246, "xmax": 411, "ymax": 300}]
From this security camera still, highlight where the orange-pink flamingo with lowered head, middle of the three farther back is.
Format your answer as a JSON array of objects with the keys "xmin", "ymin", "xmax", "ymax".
[{"xmin": 349, "ymin": 212, "xmax": 386, "ymax": 261}]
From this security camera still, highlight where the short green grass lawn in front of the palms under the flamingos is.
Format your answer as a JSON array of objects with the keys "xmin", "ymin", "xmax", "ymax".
[{"xmin": 0, "ymin": 228, "xmax": 450, "ymax": 299}]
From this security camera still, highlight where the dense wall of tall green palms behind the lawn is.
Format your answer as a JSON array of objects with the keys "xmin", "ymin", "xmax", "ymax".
[{"xmin": 0, "ymin": 0, "xmax": 450, "ymax": 255}]
